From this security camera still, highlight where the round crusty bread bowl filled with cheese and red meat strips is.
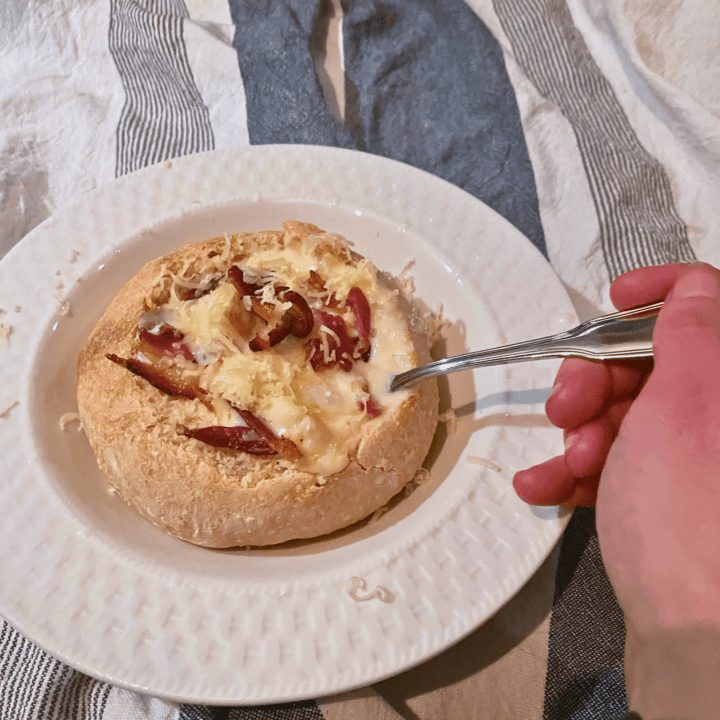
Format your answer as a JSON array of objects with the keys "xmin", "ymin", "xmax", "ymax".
[{"xmin": 76, "ymin": 221, "xmax": 438, "ymax": 548}]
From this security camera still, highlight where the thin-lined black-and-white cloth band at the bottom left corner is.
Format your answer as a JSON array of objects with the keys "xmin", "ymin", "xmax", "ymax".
[{"xmin": 0, "ymin": 622, "xmax": 111, "ymax": 720}]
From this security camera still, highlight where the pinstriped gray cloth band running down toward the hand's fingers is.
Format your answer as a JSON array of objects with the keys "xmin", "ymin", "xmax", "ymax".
[{"xmin": 493, "ymin": 0, "xmax": 695, "ymax": 278}]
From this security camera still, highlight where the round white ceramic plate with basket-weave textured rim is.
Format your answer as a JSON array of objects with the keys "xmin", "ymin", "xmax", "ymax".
[{"xmin": 0, "ymin": 146, "xmax": 576, "ymax": 704}]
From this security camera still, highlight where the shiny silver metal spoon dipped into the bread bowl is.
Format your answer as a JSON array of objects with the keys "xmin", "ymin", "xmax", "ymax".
[{"xmin": 390, "ymin": 303, "xmax": 662, "ymax": 391}]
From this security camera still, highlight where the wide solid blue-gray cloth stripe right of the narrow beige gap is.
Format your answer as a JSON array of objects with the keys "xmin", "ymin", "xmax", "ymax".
[{"xmin": 343, "ymin": 0, "xmax": 547, "ymax": 256}]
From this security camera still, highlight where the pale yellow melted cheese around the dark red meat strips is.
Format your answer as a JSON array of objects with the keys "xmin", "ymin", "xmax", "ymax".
[{"xmin": 158, "ymin": 236, "xmax": 413, "ymax": 475}]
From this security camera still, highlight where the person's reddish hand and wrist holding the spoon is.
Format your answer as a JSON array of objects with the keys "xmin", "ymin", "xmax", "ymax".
[{"xmin": 515, "ymin": 264, "xmax": 720, "ymax": 718}]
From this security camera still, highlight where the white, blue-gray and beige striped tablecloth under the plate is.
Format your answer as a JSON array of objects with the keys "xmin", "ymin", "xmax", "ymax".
[{"xmin": 0, "ymin": 0, "xmax": 720, "ymax": 720}]
